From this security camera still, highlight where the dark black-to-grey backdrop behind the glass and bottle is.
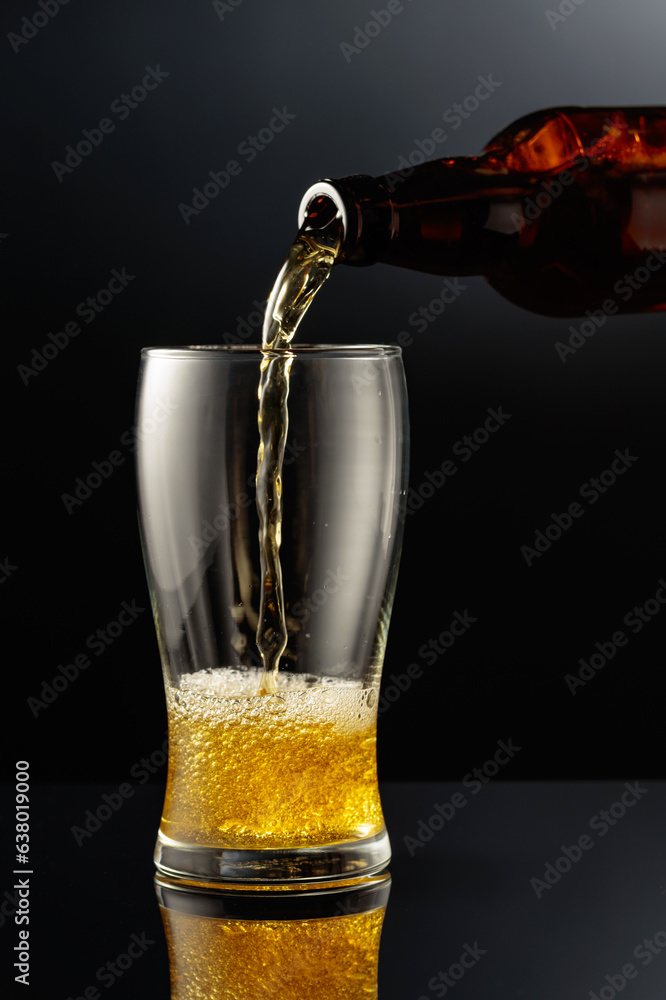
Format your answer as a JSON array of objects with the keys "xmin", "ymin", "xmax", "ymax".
[{"xmin": 0, "ymin": 0, "xmax": 666, "ymax": 782}]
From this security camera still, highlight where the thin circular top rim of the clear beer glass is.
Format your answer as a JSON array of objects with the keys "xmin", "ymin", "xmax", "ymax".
[{"xmin": 141, "ymin": 344, "xmax": 402, "ymax": 360}]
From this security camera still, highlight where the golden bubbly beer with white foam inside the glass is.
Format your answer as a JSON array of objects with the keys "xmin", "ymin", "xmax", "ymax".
[{"xmin": 160, "ymin": 668, "xmax": 384, "ymax": 849}]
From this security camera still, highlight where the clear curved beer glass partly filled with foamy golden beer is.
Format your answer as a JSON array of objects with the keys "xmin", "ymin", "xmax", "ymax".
[{"xmin": 137, "ymin": 345, "xmax": 408, "ymax": 882}]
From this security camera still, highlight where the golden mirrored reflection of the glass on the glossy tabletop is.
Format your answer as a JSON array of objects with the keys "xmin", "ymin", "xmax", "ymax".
[{"xmin": 156, "ymin": 875, "xmax": 390, "ymax": 1000}]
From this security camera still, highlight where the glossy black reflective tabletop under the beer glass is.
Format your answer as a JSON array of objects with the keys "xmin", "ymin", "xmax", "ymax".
[{"xmin": 0, "ymin": 777, "xmax": 666, "ymax": 1000}]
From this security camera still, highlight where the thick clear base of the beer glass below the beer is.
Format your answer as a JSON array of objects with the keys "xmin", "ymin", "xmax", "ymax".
[{"xmin": 154, "ymin": 829, "xmax": 391, "ymax": 883}]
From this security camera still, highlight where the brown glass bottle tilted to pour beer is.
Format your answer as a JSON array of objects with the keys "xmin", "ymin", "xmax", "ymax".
[{"xmin": 300, "ymin": 107, "xmax": 666, "ymax": 316}]
